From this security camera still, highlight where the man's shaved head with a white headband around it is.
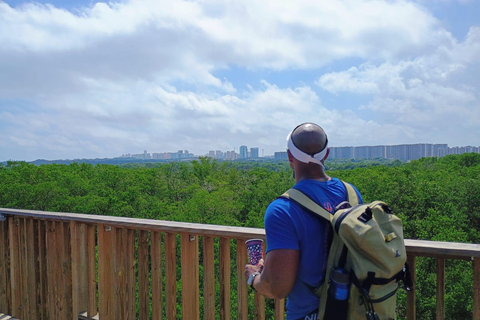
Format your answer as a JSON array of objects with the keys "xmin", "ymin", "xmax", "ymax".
[{"xmin": 287, "ymin": 122, "xmax": 328, "ymax": 167}]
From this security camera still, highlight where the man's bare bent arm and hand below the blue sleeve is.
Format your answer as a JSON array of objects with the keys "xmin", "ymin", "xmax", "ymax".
[{"xmin": 245, "ymin": 249, "xmax": 300, "ymax": 299}]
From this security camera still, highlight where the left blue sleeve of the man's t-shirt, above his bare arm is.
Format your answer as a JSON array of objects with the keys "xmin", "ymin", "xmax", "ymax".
[{"xmin": 264, "ymin": 199, "xmax": 300, "ymax": 252}]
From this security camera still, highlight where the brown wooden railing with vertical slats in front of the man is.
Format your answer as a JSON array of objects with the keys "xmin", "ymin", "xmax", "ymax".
[{"xmin": 0, "ymin": 209, "xmax": 480, "ymax": 320}]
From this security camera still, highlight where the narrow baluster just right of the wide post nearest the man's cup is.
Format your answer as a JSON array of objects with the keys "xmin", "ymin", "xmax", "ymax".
[{"xmin": 203, "ymin": 237, "xmax": 215, "ymax": 320}]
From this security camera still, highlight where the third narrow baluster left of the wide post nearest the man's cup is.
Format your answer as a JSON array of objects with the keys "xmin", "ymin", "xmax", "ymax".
[{"xmin": 138, "ymin": 230, "xmax": 150, "ymax": 320}]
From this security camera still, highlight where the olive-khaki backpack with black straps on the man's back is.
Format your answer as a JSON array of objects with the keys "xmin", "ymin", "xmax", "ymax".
[{"xmin": 282, "ymin": 183, "xmax": 411, "ymax": 320}]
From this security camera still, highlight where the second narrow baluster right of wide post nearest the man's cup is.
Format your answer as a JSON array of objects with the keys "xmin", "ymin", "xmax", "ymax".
[{"xmin": 219, "ymin": 238, "xmax": 231, "ymax": 320}]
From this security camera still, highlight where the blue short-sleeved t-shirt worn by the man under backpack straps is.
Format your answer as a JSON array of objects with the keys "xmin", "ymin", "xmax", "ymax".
[{"xmin": 265, "ymin": 178, "xmax": 362, "ymax": 319}]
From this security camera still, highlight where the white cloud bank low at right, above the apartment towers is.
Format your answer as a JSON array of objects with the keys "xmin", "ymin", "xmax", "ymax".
[{"xmin": 317, "ymin": 27, "xmax": 480, "ymax": 144}]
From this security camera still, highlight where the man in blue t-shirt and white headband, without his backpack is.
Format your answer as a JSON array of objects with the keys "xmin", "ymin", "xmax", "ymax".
[{"xmin": 245, "ymin": 123, "xmax": 362, "ymax": 320}]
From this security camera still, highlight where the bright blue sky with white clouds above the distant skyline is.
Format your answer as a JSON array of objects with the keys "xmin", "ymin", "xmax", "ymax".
[{"xmin": 0, "ymin": 0, "xmax": 480, "ymax": 161}]
